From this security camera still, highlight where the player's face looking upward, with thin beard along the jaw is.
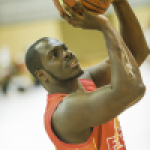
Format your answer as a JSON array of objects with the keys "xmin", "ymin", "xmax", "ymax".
[{"xmin": 36, "ymin": 38, "xmax": 83, "ymax": 81}]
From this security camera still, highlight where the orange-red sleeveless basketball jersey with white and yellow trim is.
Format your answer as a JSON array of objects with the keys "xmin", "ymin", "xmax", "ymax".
[{"xmin": 44, "ymin": 79, "xmax": 126, "ymax": 150}]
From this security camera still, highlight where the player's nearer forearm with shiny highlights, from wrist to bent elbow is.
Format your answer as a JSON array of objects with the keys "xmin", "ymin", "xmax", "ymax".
[{"xmin": 102, "ymin": 21, "xmax": 143, "ymax": 88}]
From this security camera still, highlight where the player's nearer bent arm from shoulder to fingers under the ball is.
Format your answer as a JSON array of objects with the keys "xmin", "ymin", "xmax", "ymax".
[{"xmin": 53, "ymin": 4, "xmax": 145, "ymax": 132}]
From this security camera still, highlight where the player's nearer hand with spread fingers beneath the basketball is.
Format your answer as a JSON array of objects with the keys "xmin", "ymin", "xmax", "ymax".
[{"xmin": 60, "ymin": 0, "xmax": 108, "ymax": 30}]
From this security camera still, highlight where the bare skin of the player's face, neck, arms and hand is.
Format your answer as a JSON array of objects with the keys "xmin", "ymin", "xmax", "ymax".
[{"xmin": 36, "ymin": 0, "xmax": 148, "ymax": 143}]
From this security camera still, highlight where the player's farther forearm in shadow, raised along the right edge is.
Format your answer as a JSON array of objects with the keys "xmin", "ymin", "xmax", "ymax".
[{"xmin": 112, "ymin": 0, "xmax": 149, "ymax": 66}]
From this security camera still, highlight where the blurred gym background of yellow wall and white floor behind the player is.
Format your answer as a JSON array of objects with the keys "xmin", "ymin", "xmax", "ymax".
[{"xmin": 0, "ymin": 0, "xmax": 150, "ymax": 150}]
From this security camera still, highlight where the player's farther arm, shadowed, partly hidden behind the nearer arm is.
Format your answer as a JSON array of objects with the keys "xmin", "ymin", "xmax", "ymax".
[{"xmin": 87, "ymin": 0, "xmax": 150, "ymax": 87}]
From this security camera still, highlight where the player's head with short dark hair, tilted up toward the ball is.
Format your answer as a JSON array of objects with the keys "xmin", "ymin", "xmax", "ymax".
[{"xmin": 25, "ymin": 37, "xmax": 83, "ymax": 82}]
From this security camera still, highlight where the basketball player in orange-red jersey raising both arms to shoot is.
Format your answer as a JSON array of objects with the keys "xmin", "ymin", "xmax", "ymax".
[{"xmin": 26, "ymin": 0, "xmax": 148, "ymax": 150}]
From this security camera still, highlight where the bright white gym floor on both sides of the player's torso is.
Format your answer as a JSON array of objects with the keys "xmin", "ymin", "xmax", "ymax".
[{"xmin": 0, "ymin": 56, "xmax": 150, "ymax": 150}]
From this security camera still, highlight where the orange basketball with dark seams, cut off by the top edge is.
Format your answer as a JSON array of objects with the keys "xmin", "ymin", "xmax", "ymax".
[{"xmin": 53, "ymin": 0, "xmax": 111, "ymax": 14}]
